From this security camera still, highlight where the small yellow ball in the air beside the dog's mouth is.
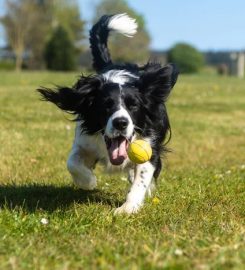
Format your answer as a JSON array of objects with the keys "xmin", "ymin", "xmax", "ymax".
[{"xmin": 128, "ymin": 140, "xmax": 152, "ymax": 164}]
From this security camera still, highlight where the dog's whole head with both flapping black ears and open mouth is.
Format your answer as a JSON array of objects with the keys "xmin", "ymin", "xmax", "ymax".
[{"xmin": 38, "ymin": 64, "xmax": 178, "ymax": 165}]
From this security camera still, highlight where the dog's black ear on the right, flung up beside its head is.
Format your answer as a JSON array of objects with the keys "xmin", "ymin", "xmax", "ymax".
[{"xmin": 139, "ymin": 64, "xmax": 179, "ymax": 102}]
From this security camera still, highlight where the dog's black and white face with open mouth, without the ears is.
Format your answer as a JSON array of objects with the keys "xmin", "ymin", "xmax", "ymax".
[{"xmin": 95, "ymin": 82, "xmax": 143, "ymax": 165}]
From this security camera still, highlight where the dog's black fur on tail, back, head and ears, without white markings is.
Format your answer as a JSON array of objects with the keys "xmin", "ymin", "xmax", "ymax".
[{"xmin": 38, "ymin": 15, "xmax": 178, "ymax": 178}]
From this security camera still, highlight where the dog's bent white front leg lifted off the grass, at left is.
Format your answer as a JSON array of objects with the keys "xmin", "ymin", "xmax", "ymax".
[{"xmin": 67, "ymin": 147, "xmax": 96, "ymax": 190}]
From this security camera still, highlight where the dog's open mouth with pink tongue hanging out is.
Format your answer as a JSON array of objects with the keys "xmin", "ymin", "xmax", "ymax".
[{"xmin": 105, "ymin": 136, "xmax": 130, "ymax": 165}]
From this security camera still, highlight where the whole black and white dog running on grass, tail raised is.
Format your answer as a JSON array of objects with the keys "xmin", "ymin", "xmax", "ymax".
[{"xmin": 38, "ymin": 14, "xmax": 178, "ymax": 213}]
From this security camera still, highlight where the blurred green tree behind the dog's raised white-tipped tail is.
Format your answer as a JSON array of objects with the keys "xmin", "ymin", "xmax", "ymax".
[{"xmin": 94, "ymin": 0, "xmax": 150, "ymax": 63}]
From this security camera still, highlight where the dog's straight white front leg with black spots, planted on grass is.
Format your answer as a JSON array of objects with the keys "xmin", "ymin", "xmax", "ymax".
[{"xmin": 115, "ymin": 162, "xmax": 155, "ymax": 214}]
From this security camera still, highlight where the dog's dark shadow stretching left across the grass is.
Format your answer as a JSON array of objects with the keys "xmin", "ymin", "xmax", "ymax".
[{"xmin": 0, "ymin": 185, "xmax": 121, "ymax": 212}]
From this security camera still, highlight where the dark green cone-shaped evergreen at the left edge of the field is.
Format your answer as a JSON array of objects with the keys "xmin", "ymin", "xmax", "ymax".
[{"xmin": 45, "ymin": 26, "xmax": 75, "ymax": 71}]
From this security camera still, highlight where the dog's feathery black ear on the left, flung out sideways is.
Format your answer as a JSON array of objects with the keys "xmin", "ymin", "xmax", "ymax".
[{"xmin": 37, "ymin": 76, "xmax": 101, "ymax": 114}]
